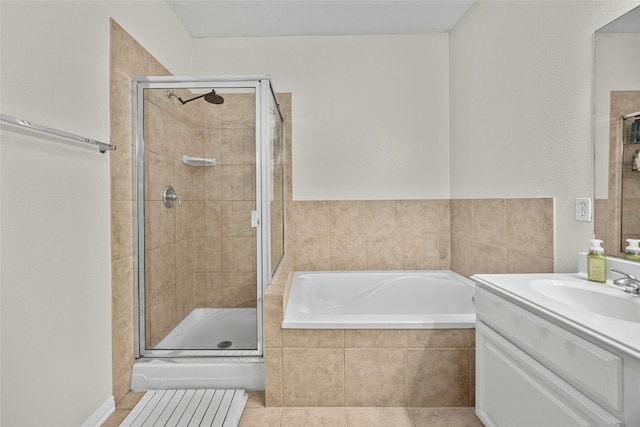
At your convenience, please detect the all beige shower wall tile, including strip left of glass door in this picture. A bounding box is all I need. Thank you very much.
[110,20,256,402]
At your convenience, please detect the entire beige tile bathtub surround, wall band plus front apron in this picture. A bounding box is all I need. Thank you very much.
[265,198,554,412]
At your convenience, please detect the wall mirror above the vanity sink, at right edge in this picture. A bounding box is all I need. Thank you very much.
[594,6,640,256]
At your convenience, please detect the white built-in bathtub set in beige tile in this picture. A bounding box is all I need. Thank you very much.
[282,270,476,329]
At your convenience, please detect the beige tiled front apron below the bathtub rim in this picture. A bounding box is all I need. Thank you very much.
[265,329,475,407]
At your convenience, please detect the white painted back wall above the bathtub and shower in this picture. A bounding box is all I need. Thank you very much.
[194,34,449,200]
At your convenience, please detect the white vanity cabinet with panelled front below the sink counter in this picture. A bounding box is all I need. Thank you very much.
[476,282,640,427]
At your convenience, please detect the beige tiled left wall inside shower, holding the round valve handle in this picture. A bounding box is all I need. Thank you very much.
[144,89,202,347]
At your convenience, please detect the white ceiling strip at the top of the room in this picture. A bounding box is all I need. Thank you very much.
[167,0,474,38]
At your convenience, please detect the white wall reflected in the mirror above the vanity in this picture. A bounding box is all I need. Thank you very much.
[595,33,640,199]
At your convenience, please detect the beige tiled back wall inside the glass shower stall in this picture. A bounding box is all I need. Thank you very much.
[192,94,256,308]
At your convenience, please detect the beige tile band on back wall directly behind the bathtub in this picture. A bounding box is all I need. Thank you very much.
[291,200,450,270]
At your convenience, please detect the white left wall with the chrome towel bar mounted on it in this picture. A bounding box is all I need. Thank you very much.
[0,1,192,426]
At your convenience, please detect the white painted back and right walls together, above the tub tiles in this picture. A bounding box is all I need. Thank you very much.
[194,1,638,271]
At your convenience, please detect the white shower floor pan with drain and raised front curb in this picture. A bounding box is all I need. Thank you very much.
[131,308,264,391]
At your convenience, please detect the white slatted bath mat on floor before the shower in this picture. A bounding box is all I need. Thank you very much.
[120,390,247,427]
